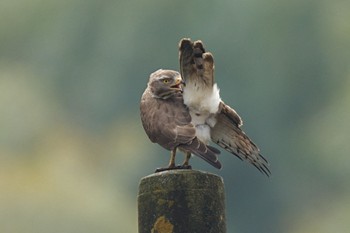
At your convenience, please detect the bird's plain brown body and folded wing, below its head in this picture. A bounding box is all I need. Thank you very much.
[140,90,221,168]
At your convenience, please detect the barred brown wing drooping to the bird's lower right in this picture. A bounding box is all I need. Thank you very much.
[210,102,271,176]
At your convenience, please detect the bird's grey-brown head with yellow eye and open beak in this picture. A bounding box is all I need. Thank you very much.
[148,69,184,99]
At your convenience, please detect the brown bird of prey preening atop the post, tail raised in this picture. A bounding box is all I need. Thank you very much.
[140,39,271,176]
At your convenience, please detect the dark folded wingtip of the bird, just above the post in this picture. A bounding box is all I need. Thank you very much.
[180,138,222,169]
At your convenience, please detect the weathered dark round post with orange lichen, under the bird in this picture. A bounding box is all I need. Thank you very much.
[138,170,226,233]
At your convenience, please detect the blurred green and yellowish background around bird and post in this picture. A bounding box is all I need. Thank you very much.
[0,0,350,233]
